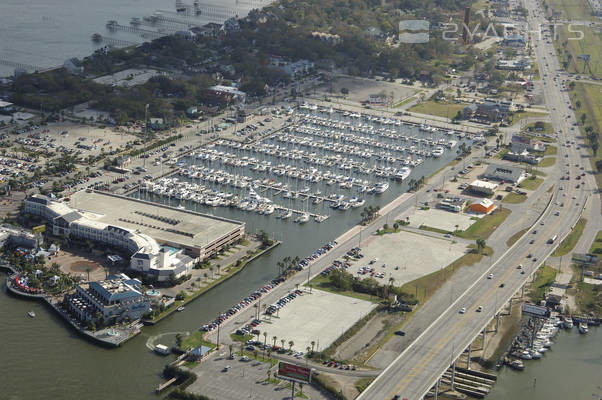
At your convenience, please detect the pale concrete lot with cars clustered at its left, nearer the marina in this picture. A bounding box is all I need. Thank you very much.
[348,231,466,286]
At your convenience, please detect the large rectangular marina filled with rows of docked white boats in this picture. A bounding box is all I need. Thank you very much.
[133,104,472,225]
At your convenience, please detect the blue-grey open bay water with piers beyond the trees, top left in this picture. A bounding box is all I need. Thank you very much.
[0,0,252,76]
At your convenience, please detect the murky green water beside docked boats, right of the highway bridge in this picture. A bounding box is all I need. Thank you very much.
[487,327,602,400]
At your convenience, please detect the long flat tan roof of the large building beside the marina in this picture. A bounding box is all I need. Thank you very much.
[69,191,242,248]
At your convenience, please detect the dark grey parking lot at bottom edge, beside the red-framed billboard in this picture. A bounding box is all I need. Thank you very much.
[187,349,327,400]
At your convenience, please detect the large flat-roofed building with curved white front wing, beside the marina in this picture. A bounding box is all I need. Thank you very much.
[23,191,245,281]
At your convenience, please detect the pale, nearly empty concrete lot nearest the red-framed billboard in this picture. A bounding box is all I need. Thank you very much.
[258,289,376,352]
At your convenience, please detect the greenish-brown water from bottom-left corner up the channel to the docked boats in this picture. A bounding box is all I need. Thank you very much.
[0,113,462,400]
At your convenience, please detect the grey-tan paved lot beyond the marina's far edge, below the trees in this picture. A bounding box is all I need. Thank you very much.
[321,77,416,104]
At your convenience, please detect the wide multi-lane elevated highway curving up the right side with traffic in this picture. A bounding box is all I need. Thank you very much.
[358,0,597,400]
